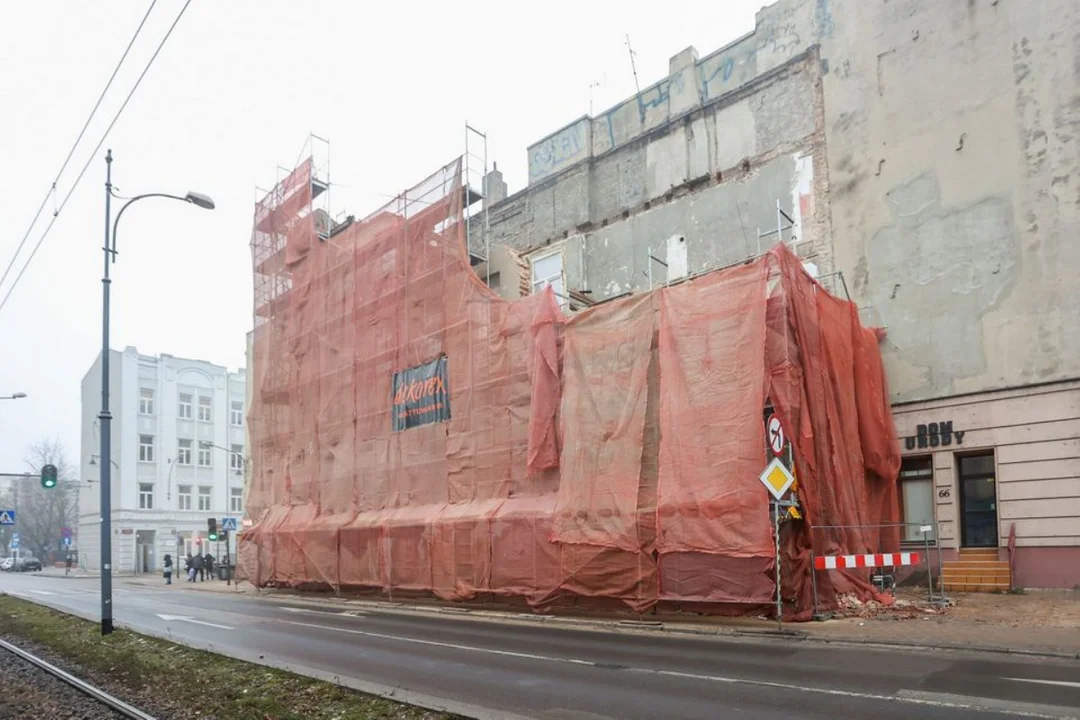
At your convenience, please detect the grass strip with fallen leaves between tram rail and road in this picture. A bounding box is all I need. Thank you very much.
[0,595,455,720]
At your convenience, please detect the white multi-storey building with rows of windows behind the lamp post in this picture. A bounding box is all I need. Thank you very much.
[78,347,247,573]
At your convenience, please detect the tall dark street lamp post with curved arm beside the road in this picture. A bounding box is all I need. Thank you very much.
[97,150,214,635]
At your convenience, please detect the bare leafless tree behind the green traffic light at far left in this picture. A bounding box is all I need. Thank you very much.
[12,438,79,559]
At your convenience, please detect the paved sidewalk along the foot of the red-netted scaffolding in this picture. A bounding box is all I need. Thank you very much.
[125,575,1080,658]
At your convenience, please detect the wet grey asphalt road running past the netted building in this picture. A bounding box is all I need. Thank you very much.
[0,573,1080,720]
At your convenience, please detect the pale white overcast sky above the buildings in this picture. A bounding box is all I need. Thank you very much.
[0,0,765,472]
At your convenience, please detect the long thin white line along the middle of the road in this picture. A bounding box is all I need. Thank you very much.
[271,620,1062,720]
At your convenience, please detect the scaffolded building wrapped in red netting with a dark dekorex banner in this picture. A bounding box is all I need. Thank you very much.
[239,156,900,619]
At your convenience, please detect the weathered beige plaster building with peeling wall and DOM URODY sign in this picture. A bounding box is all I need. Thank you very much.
[475,0,1080,586]
